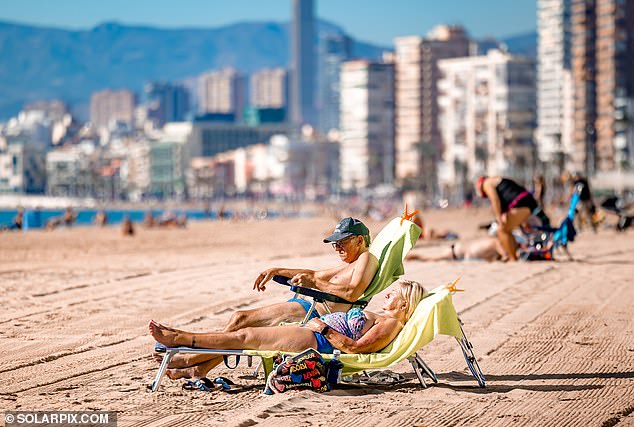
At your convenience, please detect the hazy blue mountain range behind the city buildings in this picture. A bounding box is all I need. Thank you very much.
[0,20,536,120]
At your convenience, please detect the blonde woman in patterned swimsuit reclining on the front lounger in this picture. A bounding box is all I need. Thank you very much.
[149,280,426,379]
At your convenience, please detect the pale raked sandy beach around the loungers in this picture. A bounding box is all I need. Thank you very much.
[0,209,634,427]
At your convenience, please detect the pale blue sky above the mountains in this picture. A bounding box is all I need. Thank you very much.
[0,0,536,45]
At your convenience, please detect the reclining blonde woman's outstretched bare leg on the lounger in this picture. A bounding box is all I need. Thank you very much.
[149,321,317,351]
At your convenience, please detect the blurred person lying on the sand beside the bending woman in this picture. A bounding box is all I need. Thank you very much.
[405,237,506,261]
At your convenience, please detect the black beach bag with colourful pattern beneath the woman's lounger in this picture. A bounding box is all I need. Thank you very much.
[266,348,330,394]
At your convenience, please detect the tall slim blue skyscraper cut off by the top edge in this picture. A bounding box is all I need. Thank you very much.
[290,0,318,126]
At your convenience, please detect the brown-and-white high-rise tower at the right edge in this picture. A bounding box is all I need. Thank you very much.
[571,0,634,175]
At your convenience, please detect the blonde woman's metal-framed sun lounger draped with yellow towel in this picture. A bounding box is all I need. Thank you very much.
[152,286,485,391]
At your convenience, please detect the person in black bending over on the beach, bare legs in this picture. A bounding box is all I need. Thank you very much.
[475,176,538,261]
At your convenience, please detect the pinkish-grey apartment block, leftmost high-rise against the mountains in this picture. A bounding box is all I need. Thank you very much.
[90,90,136,127]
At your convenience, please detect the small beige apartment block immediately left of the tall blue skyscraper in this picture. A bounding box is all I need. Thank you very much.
[251,68,288,109]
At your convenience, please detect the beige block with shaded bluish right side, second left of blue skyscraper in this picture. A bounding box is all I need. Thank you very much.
[199,68,245,121]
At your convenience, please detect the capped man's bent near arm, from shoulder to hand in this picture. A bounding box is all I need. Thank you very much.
[291,251,379,301]
